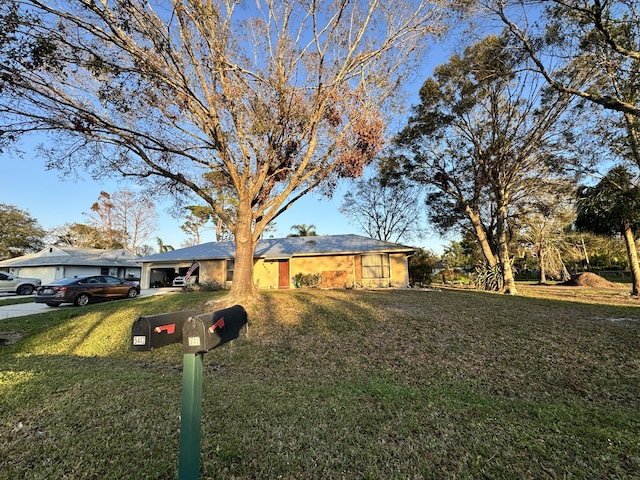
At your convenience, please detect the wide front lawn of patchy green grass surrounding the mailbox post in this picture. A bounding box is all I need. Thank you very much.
[0,290,640,479]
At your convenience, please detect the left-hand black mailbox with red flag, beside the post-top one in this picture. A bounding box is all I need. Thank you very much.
[131,310,200,352]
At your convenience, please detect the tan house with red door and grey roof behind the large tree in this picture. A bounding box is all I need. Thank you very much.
[140,235,415,289]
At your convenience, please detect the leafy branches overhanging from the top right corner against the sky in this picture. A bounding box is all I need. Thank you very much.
[490,0,640,117]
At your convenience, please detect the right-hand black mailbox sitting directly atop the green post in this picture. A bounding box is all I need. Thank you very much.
[182,305,247,353]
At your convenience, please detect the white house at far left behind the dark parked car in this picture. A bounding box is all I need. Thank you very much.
[0,246,140,284]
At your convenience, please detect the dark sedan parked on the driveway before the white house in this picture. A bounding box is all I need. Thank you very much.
[36,275,140,307]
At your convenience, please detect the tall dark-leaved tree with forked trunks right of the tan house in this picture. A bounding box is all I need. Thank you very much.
[385,35,571,293]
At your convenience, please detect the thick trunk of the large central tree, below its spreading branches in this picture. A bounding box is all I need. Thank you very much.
[229,201,258,302]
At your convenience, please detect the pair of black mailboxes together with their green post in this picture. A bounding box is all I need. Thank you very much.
[131,305,247,480]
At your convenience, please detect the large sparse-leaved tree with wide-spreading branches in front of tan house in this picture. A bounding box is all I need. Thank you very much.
[0,0,459,298]
